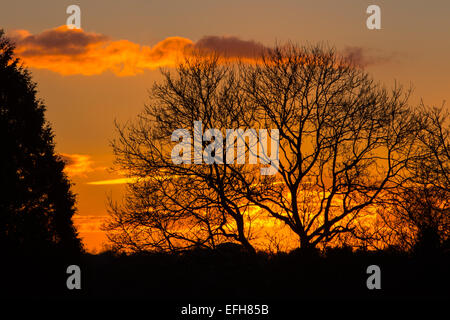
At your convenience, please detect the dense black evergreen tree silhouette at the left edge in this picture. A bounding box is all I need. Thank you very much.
[0,30,82,252]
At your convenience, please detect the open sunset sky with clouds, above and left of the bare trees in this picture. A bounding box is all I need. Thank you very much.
[0,0,450,251]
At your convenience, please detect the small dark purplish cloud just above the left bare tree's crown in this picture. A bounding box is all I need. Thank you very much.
[194,36,267,58]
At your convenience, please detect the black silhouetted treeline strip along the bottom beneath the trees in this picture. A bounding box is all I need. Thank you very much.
[0,248,450,303]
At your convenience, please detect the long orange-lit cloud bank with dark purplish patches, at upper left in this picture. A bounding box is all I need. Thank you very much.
[9,26,270,76]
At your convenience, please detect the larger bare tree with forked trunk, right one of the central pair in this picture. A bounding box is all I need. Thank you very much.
[238,44,414,248]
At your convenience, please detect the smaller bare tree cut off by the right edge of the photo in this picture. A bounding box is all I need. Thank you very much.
[380,104,450,252]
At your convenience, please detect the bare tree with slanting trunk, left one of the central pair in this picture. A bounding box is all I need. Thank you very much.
[106,52,256,252]
